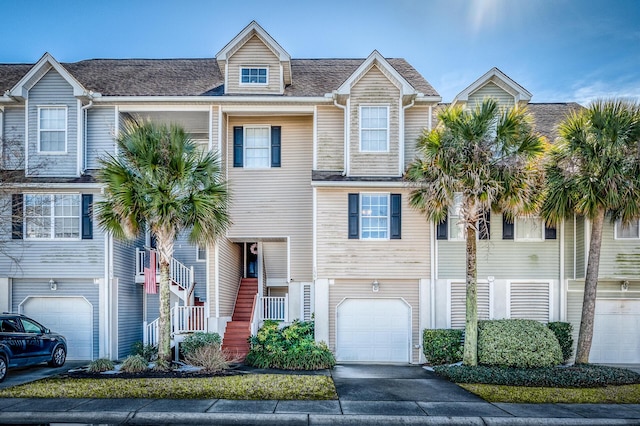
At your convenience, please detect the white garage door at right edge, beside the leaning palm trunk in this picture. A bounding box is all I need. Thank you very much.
[589,299,640,364]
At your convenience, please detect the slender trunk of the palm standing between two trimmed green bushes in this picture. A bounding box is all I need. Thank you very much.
[462,226,478,366]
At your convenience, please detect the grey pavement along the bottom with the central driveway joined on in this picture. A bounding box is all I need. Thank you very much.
[0,364,640,426]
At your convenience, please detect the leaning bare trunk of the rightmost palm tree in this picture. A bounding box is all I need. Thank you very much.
[575,208,605,364]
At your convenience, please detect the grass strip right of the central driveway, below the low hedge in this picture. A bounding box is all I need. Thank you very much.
[459,383,640,404]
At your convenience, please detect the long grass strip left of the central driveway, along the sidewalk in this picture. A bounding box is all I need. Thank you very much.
[0,374,338,400]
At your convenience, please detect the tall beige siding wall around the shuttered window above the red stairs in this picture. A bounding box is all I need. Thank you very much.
[225,116,313,282]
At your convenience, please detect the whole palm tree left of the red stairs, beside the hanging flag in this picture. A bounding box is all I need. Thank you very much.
[96,120,229,368]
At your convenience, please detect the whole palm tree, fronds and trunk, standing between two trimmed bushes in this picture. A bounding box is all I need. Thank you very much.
[405,99,545,365]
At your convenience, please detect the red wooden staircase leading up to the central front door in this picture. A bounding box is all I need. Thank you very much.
[222,278,258,361]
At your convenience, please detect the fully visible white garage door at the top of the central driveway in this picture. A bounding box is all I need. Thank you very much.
[336,299,411,362]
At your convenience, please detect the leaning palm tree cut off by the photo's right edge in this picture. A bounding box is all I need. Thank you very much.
[542,100,640,364]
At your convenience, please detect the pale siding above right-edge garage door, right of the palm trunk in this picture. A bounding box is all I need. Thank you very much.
[598,218,640,278]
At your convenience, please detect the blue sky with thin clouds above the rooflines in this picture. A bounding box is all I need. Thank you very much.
[0,0,640,105]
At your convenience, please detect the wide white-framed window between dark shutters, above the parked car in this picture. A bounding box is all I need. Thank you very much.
[24,194,81,239]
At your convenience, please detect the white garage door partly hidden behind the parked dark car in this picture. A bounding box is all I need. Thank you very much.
[22,297,93,360]
